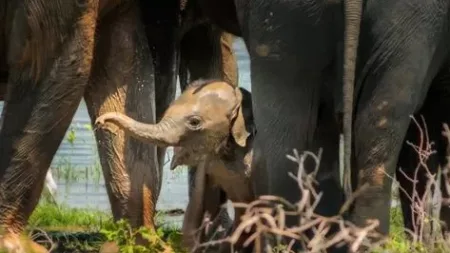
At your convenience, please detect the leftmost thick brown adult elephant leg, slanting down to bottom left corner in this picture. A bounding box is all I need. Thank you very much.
[0,1,97,249]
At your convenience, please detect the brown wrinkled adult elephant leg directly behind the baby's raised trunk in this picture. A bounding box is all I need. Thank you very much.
[85,5,162,228]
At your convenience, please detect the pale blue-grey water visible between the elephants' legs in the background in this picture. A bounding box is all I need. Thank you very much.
[0,39,251,221]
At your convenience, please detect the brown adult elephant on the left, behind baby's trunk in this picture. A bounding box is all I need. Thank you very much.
[0,0,236,250]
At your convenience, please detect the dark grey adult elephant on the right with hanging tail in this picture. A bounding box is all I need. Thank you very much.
[194,0,450,248]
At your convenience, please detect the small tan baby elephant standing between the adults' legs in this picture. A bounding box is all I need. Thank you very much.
[96,80,255,252]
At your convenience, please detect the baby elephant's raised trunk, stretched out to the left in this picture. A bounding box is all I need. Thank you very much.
[96,112,183,147]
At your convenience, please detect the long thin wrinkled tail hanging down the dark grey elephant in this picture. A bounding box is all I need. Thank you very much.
[343,0,362,197]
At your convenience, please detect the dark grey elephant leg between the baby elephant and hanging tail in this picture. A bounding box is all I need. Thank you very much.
[244,1,338,251]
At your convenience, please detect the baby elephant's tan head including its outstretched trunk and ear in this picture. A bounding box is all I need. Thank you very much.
[96,80,253,169]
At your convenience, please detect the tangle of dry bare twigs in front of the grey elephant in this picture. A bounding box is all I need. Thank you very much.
[195,147,383,253]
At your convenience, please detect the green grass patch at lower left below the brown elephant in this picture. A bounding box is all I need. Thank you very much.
[27,201,183,253]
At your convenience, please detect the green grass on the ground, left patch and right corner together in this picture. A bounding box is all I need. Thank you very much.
[22,201,449,253]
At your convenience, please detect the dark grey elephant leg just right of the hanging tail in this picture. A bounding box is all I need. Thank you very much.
[350,1,447,234]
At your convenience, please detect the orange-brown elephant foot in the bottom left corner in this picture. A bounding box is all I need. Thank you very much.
[0,233,48,253]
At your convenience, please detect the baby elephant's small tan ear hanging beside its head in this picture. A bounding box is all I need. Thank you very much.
[231,87,250,147]
